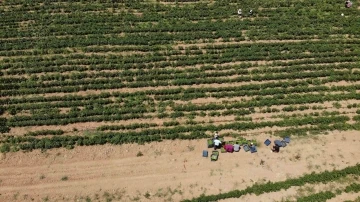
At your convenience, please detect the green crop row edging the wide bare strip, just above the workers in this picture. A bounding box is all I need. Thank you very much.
[1,116,359,151]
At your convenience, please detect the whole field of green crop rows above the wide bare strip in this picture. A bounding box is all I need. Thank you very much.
[0,0,360,151]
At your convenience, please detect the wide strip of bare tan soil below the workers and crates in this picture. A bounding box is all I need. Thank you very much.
[0,131,360,201]
